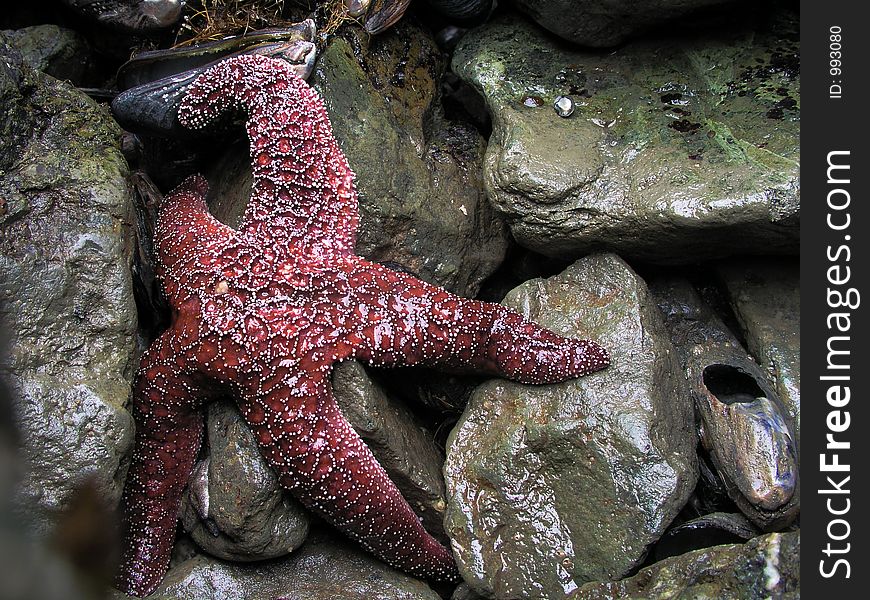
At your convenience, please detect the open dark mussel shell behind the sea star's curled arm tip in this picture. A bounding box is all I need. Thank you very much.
[112,19,317,137]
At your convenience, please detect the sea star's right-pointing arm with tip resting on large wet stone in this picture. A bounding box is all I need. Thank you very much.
[350,260,610,383]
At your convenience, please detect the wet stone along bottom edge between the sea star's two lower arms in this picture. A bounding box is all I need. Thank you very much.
[121,536,439,600]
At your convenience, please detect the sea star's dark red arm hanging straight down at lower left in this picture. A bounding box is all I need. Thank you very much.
[117,330,211,596]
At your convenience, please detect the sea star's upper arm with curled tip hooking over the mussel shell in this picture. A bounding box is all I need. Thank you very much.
[178,55,359,258]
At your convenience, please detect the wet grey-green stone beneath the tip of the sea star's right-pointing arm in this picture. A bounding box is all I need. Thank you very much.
[445,254,698,599]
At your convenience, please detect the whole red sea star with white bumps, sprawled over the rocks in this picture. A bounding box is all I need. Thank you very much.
[119,55,609,595]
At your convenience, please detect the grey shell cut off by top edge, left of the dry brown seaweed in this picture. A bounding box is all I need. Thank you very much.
[63,0,184,33]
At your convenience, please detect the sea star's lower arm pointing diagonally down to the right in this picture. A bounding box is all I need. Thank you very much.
[240,368,458,581]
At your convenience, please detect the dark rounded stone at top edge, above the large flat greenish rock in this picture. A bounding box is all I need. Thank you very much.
[513,0,733,47]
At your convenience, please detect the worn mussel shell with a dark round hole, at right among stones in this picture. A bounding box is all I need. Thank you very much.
[650,279,800,531]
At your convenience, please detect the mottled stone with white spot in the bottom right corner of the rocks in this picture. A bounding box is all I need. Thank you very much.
[572,532,800,600]
